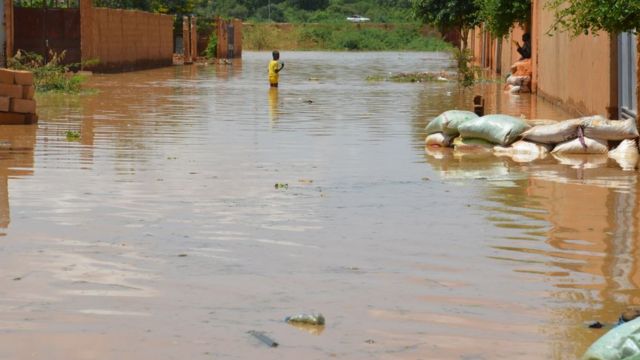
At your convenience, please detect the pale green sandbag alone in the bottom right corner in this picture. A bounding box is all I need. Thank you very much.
[581,318,640,360]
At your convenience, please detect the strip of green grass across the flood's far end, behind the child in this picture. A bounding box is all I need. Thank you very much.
[243,23,452,51]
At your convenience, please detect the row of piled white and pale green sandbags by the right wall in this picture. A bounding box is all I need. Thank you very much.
[426,110,640,170]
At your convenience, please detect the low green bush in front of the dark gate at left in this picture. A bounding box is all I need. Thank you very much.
[8,50,84,93]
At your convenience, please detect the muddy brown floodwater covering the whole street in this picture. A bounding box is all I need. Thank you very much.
[0,52,640,360]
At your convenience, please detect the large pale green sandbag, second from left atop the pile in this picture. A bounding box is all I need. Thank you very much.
[458,115,529,146]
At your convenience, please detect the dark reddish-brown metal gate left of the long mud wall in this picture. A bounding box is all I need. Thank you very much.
[14,2,81,64]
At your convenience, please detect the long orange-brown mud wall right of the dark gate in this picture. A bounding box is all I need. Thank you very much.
[80,0,173,71]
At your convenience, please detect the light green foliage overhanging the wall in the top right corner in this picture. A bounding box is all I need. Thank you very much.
[547,0,640,36]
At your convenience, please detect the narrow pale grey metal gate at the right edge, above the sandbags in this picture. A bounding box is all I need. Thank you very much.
[618,32,638,119]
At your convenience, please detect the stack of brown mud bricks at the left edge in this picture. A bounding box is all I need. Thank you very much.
[0,69,38,125]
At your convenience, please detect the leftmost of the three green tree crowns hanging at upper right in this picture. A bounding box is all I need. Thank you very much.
[413,0,481,50]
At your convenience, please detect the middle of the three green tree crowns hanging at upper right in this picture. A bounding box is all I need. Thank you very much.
[477,0,531,37]
